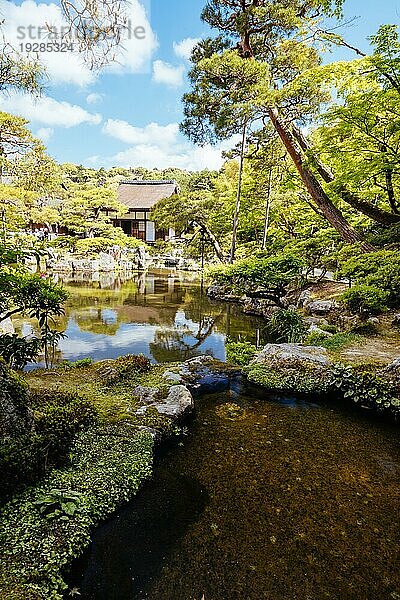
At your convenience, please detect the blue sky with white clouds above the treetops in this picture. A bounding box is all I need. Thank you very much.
[0,0,400,170]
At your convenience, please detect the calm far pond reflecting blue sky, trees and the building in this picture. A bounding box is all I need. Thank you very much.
[20,271,265,363]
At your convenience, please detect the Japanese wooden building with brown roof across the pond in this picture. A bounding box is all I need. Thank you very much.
[114,181,178,244]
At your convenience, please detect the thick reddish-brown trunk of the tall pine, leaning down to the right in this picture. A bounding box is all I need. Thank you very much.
[268,108,374,252]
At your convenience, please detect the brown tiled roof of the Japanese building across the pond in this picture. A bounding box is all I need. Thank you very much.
[118,181,178,209]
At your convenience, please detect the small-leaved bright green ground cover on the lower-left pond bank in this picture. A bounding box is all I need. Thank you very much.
[0,426,153,600]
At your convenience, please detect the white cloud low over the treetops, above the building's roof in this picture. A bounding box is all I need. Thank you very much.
[88,119,240,171]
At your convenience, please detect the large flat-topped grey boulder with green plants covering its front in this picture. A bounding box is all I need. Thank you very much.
[244,344,333,394]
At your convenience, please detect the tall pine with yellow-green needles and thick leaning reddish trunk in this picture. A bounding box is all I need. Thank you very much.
[182,0,378,250]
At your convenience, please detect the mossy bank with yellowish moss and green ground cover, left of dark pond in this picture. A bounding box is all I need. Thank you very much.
[0,358,183,600]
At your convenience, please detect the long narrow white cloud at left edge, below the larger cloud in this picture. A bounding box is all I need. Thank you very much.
[0,93,101,127]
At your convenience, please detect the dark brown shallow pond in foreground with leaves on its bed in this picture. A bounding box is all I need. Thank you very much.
[70,380,400,600]
